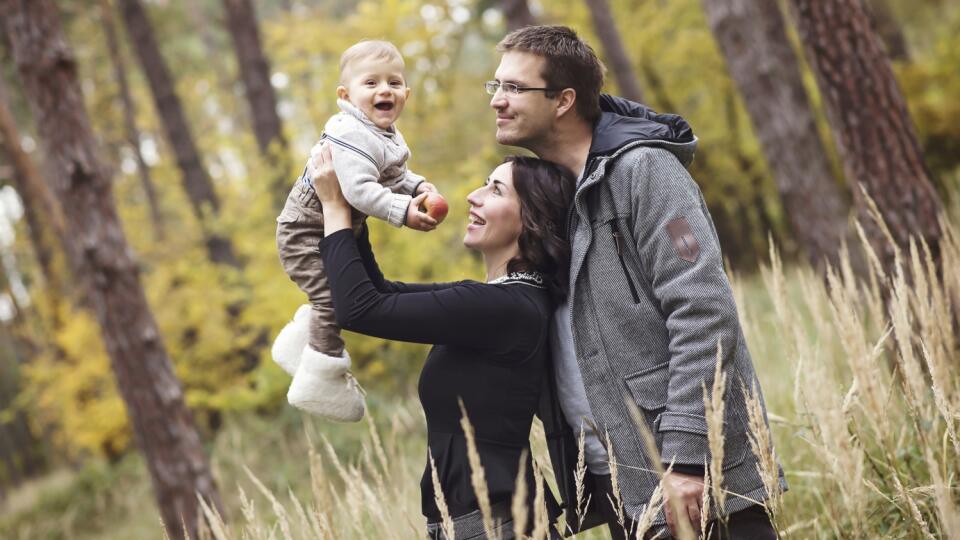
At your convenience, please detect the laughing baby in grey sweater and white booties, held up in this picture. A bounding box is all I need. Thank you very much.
[272,40,437,422]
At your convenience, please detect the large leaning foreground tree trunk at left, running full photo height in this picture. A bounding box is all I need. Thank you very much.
[0,0,221,539]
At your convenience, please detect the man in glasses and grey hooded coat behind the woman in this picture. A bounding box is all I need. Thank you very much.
[487,26,786,538]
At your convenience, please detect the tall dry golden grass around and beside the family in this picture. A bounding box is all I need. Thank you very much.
[0,220,960,540]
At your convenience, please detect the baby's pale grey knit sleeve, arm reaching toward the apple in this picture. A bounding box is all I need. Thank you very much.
[324,129,411,227]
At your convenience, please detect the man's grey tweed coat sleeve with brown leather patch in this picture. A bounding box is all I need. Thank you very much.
[631,147,741,467]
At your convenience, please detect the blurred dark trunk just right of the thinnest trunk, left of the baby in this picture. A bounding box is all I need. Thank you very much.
[119,0,239,266]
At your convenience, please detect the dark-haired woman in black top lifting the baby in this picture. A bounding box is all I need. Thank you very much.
[311,144,574,539]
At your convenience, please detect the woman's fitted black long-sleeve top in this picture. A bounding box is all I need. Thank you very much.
[320,229,552,521]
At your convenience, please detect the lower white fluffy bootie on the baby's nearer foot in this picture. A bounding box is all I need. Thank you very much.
[287,346,366,422]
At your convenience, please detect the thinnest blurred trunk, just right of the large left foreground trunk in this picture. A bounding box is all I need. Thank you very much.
[100,0,164,241]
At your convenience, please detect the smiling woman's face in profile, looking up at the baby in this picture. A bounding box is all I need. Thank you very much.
[463,163,523,255]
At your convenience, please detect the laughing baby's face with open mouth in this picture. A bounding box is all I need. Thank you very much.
[337,58,410,129]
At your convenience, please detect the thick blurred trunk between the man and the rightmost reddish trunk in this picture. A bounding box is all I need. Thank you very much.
[703,0,847,270]
